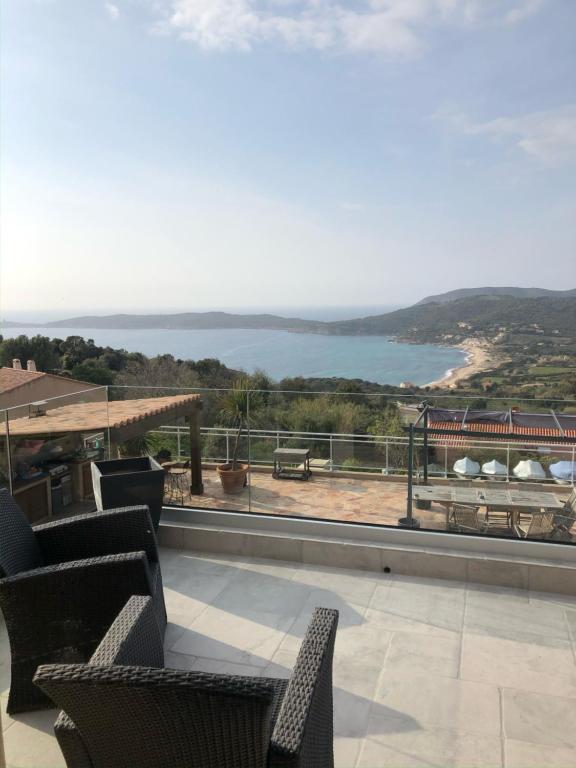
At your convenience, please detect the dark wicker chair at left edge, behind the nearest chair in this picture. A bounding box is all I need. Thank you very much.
[0,489,166,714]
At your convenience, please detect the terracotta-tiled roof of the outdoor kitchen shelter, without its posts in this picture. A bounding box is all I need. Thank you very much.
[0,394,202,442]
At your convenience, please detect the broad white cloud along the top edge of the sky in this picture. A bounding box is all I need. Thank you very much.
[155,0,547,55]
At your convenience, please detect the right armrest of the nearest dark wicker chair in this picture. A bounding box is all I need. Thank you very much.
[268,608,338,768]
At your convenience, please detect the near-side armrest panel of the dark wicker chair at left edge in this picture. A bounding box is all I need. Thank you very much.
[0,552,151,663]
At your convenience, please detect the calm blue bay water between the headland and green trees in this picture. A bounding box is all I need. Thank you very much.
[2,324,466,385]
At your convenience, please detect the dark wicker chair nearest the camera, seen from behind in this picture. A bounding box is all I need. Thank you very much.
[35,597,338,768]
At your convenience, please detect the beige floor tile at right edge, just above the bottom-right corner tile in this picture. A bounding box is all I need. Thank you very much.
[502,688,576,748]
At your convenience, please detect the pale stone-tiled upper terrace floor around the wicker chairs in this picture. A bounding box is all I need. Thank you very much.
[0,548,576,768]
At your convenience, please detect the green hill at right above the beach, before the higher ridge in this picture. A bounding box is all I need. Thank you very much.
[326,296,576,341]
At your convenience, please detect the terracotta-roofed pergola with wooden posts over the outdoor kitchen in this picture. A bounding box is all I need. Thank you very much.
[0,394,204,495]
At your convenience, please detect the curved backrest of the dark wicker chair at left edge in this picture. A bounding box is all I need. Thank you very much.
[0,488,44,578]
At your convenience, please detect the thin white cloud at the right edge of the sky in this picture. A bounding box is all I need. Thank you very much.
[434,104,576,166]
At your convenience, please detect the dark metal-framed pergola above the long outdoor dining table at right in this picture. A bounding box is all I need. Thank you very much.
[400,402,576,528]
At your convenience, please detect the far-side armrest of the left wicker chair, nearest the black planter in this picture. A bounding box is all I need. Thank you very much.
[34,506,158,564]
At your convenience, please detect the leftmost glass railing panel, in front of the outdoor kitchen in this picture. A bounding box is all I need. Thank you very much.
[1,387,109,523]
